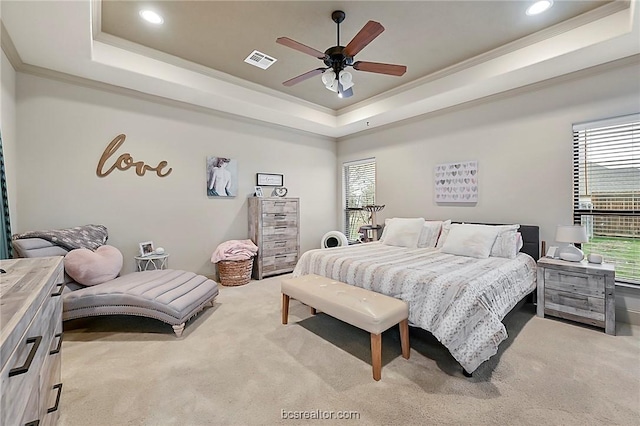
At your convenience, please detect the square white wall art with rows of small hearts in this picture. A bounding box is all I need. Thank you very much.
[435,161,478,203]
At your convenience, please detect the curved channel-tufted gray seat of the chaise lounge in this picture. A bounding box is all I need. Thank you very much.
[62,269,218,337]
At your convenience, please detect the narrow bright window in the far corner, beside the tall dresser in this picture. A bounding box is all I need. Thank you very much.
[343,158,376,241]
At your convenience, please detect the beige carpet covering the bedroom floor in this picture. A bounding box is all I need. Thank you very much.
[59,277,640,426]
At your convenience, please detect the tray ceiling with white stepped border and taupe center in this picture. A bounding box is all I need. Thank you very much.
[0,0,640,137]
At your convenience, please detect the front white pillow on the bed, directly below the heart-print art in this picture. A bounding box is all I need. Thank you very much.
[442,224,499,259]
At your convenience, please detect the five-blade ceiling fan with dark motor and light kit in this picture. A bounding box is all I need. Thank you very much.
[276,10,407,97]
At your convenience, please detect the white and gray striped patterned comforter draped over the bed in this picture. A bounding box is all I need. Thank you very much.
[293,242,536,373]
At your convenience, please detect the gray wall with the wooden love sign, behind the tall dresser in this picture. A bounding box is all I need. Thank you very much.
[14,73,338,275]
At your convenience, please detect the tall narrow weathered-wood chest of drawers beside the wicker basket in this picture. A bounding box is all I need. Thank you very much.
[249,197,300,280]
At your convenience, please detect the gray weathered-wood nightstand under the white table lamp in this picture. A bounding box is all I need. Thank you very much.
[537,257,616,335]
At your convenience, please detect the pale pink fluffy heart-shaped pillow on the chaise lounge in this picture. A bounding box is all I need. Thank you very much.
[64,245,123,285]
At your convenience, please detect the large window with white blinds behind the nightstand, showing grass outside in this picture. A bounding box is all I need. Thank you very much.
[573,114,640,284]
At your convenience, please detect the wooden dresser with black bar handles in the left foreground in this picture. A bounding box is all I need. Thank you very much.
[0,256,64,426]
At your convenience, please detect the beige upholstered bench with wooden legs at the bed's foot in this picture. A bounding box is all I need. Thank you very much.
[281,275,409,380]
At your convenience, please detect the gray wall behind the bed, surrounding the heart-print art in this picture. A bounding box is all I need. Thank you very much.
[338,61,640,319]
